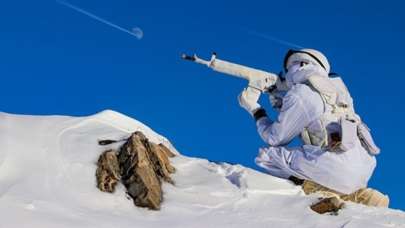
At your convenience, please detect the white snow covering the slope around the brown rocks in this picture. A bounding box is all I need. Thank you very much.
[0,110,405,228]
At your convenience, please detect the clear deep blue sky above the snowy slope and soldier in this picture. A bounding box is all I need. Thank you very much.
[0,0,405,209]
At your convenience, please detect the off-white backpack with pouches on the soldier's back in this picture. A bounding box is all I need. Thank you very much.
[301,74,380,155]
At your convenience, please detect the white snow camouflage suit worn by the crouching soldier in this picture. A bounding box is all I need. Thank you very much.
[255,65,376,194]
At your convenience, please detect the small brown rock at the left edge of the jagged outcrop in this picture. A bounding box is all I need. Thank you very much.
[96,150,121,192]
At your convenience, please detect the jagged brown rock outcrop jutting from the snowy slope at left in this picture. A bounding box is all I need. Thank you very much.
[96,131,175,210]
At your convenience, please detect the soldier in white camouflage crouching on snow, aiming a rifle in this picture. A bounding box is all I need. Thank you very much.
[239,49,389,207]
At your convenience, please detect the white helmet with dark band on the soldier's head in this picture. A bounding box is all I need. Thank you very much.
[284,49,330,74]
